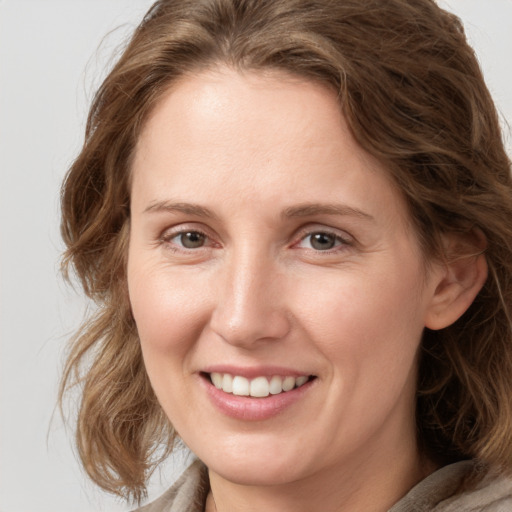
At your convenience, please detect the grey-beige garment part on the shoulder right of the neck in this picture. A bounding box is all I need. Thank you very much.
[389,461,512,512]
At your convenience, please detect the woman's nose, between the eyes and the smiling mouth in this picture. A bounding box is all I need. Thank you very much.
[210,245,290,349]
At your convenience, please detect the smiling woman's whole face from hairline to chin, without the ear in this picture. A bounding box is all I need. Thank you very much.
[128,68,435,484]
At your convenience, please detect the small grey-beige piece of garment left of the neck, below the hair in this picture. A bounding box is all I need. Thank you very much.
[133,460,209,512]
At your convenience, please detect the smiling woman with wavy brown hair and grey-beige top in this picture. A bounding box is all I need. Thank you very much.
[62,0,512,512]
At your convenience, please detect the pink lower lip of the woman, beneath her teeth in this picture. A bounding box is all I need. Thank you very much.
[201,378,316,421]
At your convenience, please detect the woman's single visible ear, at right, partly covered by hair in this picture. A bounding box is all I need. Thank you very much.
[425,229,487,330]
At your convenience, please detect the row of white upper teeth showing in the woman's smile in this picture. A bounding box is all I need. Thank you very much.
[210,373,309,398]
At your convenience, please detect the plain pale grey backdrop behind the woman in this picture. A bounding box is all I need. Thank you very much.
[0,0,512,512]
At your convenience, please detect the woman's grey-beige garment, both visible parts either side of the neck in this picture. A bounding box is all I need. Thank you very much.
[134,460,512,512]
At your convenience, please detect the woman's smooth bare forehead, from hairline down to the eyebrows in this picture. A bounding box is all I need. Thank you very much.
[132,68,403,230]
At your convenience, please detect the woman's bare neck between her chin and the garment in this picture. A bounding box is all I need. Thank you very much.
[206,440,435,512]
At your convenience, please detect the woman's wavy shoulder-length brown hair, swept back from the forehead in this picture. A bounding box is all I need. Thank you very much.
[60,0,512,500]
